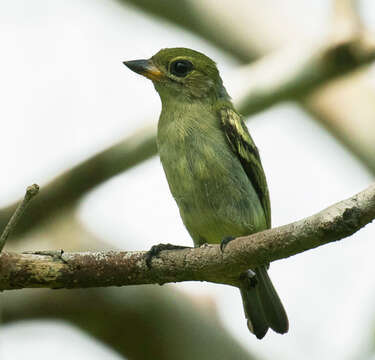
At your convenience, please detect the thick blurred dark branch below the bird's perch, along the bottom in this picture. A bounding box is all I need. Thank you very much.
[2,286,255,360]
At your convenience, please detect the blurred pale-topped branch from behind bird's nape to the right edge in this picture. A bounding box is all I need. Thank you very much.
[235,32,375,116]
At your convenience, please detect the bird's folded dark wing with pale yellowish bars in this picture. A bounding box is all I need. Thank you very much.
[218,106,271,228]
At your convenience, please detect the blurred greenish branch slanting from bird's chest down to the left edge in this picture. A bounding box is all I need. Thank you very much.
[0,126,157,239]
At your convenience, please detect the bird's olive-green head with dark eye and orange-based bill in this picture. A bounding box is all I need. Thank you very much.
[124,48,228,101]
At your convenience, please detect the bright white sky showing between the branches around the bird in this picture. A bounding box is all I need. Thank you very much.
[0,0,375,360]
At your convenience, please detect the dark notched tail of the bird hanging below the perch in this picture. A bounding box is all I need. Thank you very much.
[240,266,289,339]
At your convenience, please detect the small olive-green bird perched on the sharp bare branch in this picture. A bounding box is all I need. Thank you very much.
[124,48,289,339]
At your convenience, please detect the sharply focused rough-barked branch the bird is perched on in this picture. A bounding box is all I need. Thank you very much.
[0,184,375,290]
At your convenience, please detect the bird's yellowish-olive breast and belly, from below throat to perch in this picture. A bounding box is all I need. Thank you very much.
[158,105,264,244]
